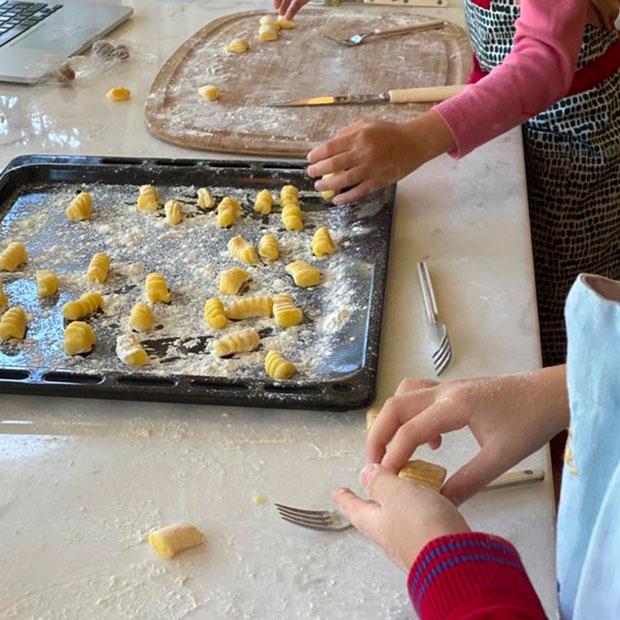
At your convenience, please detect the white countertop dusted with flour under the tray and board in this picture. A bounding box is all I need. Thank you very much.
[0,0,555,619]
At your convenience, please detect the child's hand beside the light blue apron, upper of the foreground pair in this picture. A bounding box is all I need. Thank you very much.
[366,366,569,505]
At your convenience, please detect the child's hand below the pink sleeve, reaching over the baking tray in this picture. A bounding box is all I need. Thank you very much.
[307,111,455,205]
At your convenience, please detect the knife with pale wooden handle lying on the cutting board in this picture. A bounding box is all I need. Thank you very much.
[267,84,465,108]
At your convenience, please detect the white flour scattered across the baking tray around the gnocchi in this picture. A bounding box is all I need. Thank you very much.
[0,184,374,380]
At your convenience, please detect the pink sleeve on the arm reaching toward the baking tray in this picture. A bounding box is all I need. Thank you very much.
[433,0,588,157]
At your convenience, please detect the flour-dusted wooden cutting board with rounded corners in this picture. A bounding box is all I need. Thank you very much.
[146,7,471,157]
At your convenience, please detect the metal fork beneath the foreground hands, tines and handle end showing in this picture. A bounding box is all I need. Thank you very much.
[275,469,545,532]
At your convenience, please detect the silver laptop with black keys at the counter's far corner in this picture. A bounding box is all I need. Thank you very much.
[0,0,133,84]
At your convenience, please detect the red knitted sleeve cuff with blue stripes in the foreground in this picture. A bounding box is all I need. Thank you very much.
[407,532,546,620]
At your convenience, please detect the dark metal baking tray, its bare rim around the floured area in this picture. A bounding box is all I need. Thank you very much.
[0,155,395,410]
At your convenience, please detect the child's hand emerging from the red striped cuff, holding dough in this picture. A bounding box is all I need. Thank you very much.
[332,465,469,570]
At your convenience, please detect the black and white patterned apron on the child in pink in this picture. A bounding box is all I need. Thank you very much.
[465,0,620,366]
